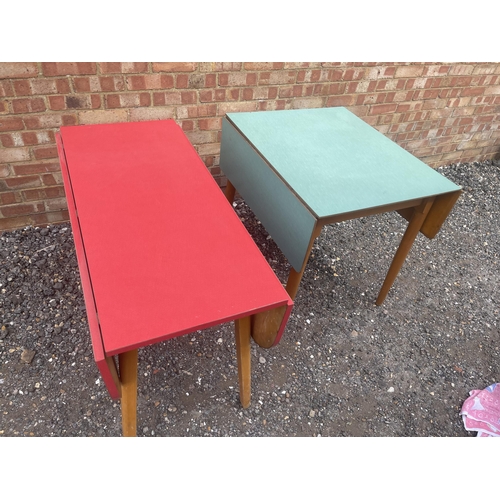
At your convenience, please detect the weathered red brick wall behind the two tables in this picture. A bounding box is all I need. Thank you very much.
[0,62,500,231]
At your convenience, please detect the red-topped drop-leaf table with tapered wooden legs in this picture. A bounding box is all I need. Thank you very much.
[57,120,292,435]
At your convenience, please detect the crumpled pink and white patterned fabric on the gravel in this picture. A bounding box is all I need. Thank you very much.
[460,384,500,437]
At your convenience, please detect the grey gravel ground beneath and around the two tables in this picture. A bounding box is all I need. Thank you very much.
[0,161,500,437]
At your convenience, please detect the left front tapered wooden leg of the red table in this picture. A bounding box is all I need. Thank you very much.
[118,349,138,437]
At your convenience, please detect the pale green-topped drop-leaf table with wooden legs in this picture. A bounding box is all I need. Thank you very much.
[220,107,461,344]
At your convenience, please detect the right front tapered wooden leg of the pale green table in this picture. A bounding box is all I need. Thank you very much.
[375,198,434,306]
